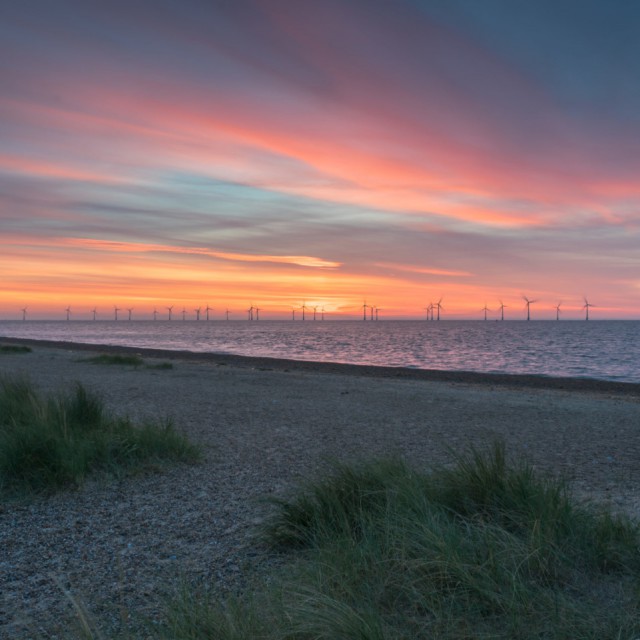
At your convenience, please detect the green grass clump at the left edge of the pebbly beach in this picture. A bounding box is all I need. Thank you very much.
[0,379,198,495]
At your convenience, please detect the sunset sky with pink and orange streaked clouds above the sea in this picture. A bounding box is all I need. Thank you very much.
[0,0,640,319]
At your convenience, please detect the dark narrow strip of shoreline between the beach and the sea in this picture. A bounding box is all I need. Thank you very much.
[0,336,640,397]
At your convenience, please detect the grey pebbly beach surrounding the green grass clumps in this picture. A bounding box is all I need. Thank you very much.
[0,338,640,638]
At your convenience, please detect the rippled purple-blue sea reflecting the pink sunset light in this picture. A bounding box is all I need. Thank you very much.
[0,320,640,383]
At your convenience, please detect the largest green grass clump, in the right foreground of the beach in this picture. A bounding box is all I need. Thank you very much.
[167,444,640,640]
